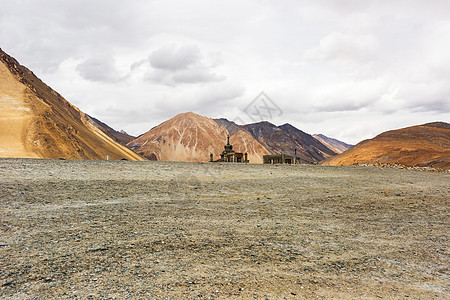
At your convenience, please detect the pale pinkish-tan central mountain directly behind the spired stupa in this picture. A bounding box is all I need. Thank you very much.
[127,112,268,163]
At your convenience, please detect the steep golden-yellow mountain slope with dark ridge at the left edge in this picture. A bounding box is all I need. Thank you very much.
[0,49,143,160]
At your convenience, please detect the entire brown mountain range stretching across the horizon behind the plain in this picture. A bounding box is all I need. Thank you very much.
[0,49,450,169]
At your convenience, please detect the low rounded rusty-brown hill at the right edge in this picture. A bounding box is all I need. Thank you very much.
[321,122,450,169]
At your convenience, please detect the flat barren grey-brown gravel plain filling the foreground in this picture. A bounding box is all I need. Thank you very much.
[0,159,450,299]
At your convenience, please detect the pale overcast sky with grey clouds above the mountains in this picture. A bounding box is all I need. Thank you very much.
[0,0,450,143]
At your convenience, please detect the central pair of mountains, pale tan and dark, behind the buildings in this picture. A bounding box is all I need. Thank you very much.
[127,112,352,163]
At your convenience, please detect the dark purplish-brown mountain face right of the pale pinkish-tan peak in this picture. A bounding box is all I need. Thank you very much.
[214,119,336,163]
